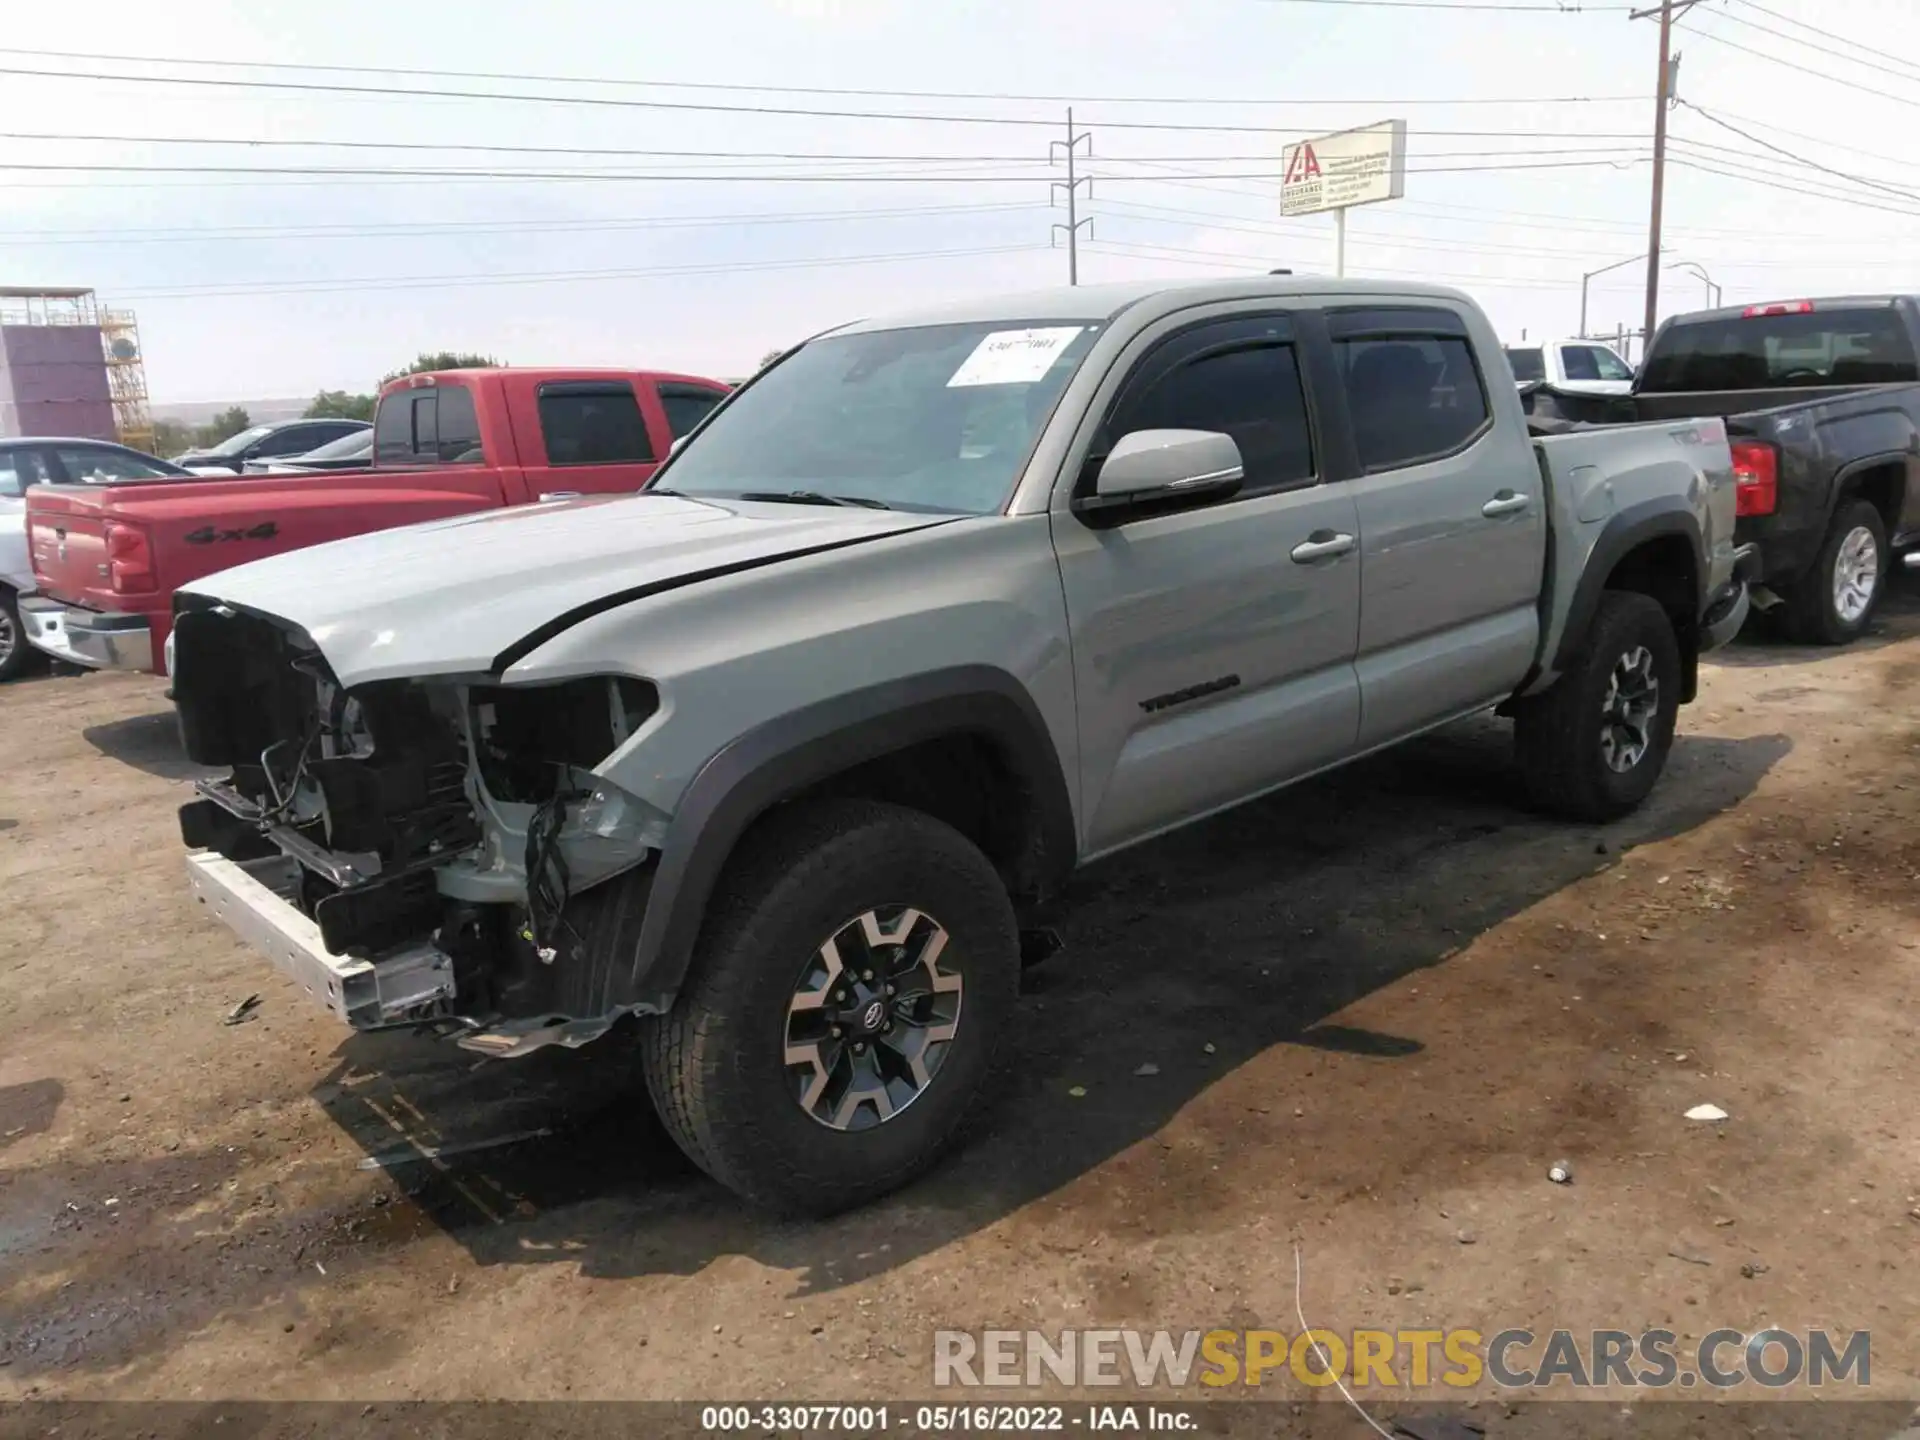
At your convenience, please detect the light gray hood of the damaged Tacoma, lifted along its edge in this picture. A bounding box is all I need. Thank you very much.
[180,495,952,685]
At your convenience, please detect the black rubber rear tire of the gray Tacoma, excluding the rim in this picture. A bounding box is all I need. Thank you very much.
[1513,589,1680,824]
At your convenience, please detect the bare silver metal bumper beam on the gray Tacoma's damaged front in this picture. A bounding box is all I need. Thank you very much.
[186,851,453,1029]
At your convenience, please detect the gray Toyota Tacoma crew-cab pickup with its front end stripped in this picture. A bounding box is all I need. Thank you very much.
[175,276,1747,1213]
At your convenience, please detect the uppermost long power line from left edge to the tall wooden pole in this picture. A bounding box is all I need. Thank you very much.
[0,44,1645,108]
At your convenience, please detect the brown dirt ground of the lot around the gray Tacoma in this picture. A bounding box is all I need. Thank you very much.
[0,584,1920,1404]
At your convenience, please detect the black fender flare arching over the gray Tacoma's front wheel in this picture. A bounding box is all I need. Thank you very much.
[620,664,1077,1010]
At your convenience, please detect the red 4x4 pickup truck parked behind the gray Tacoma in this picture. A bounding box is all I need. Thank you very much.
[19,369,728,674]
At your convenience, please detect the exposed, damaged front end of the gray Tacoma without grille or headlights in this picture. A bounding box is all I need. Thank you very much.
[175,605,668,1056]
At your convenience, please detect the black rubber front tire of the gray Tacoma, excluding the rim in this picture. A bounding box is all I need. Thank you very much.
[639,801,1020,1215]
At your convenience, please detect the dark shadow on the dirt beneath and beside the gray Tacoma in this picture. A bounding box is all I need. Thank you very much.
[299,720,1791,1292]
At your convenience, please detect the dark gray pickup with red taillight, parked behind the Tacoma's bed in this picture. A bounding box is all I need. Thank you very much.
[1521,296,1920,645]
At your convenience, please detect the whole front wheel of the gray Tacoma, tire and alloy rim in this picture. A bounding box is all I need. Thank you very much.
[641,801,1020,1215]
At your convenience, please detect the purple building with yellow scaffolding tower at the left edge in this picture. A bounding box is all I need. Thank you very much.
[0,286,154,449]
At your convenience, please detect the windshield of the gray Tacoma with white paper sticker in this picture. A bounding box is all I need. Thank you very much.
[660,321,1100,515]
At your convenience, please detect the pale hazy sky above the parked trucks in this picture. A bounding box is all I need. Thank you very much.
[0,0,1920,403]
